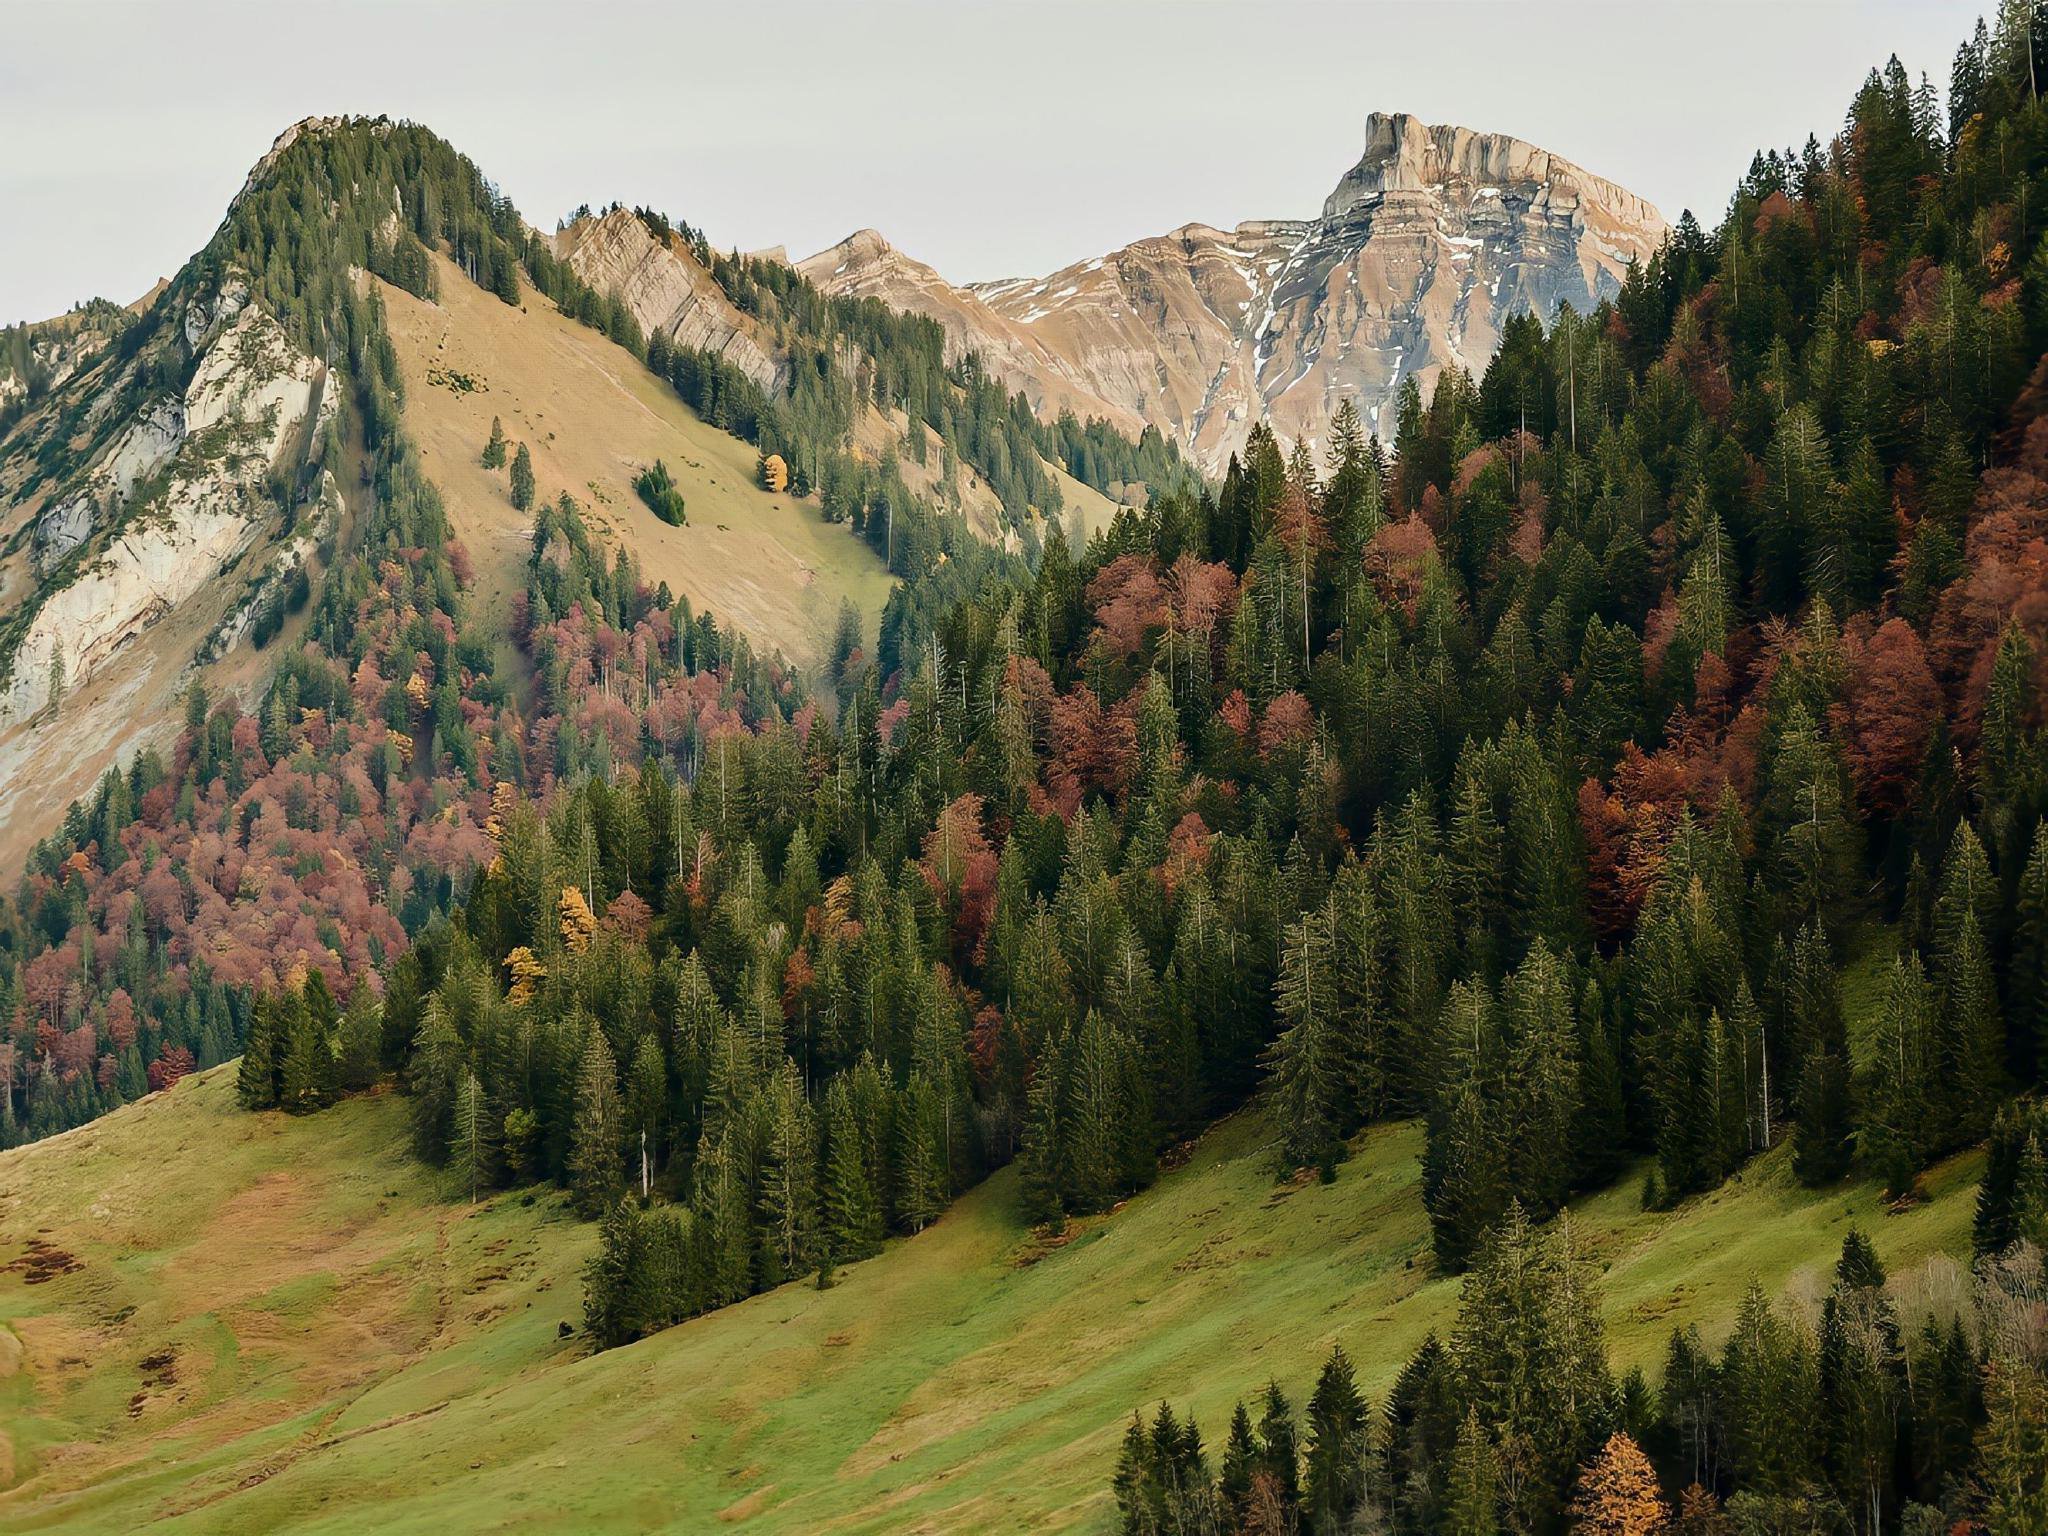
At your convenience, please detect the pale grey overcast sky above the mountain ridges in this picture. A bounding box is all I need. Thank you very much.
[0,0,1991,319]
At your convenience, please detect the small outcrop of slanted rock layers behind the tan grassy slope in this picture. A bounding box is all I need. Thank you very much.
[555,209,776,389]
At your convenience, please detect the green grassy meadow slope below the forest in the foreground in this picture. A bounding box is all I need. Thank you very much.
[0,1069,1976,1536]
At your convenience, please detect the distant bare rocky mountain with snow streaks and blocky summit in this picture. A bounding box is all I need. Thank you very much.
[799,113,1665,473]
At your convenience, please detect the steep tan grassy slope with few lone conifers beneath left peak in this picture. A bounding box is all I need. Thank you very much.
[385,250,891,664]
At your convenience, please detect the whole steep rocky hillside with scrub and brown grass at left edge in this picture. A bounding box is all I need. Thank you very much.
[0,272,348,868]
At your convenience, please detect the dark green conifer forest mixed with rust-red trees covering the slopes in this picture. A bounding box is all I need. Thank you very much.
[12,0,2048,1536]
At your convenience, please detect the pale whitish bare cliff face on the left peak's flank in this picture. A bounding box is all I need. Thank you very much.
[0,283,334,725]
